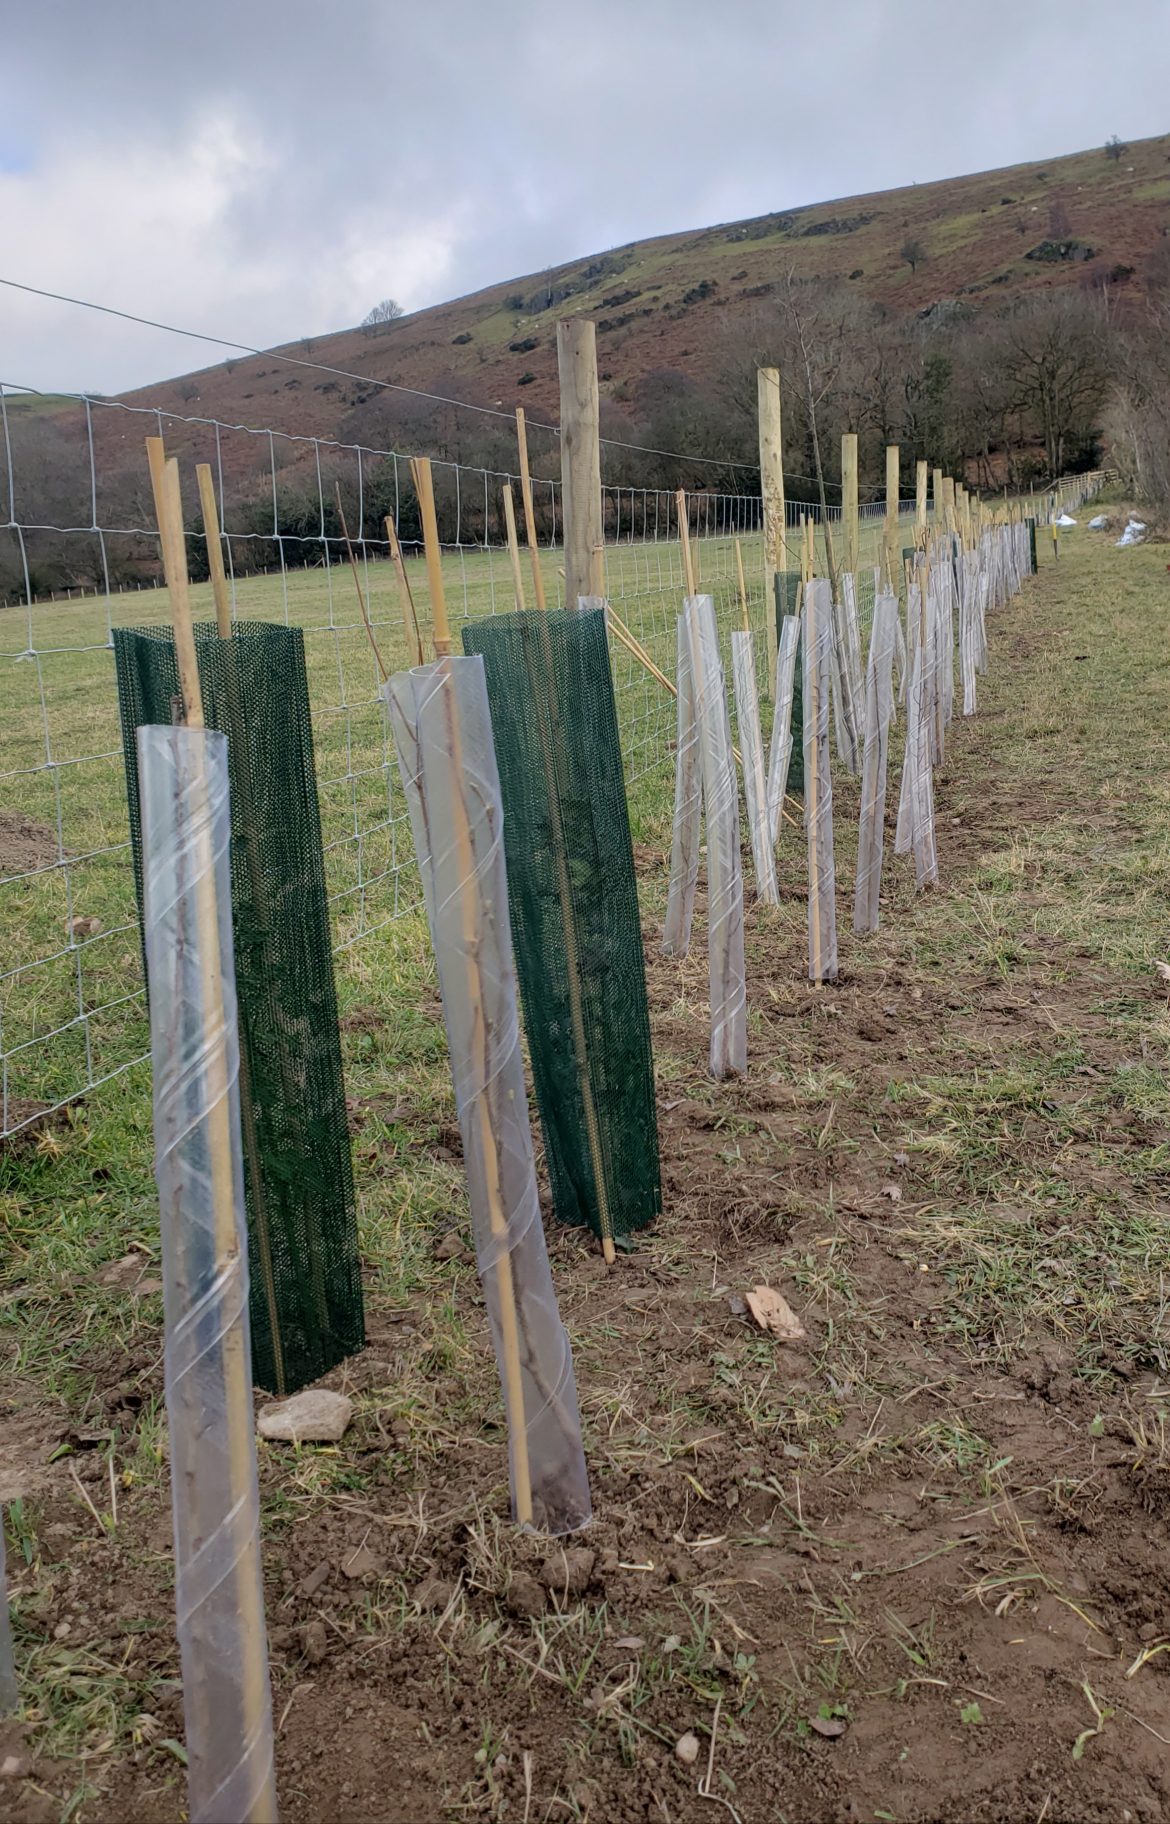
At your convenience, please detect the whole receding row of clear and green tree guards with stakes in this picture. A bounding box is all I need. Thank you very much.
[45,319,1102,1824]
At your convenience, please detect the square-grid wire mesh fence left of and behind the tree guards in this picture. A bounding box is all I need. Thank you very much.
[0,383,770,1135]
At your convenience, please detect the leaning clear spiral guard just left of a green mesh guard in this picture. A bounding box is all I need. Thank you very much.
[381,657,591,1534]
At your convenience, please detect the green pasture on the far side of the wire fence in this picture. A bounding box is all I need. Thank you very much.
[0,503,890,1133]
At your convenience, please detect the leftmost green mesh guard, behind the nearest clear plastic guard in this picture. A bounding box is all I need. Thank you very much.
[113,622,365,1394]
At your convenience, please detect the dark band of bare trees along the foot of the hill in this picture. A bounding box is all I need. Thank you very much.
[0,243,1170,602]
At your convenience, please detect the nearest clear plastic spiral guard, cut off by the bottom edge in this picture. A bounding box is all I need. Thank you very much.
[139,726,276,1824]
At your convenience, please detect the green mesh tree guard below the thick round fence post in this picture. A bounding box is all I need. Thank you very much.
[464,609,663,1238]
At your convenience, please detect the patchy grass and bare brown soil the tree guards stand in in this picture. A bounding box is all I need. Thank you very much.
[0,507,1170,1824]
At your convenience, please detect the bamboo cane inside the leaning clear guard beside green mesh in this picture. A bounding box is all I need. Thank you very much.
[411,456,533,1527]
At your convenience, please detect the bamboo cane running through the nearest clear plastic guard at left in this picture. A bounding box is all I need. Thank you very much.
[146,438,276,1824]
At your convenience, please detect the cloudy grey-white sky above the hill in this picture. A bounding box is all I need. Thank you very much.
[0,0,1170,392]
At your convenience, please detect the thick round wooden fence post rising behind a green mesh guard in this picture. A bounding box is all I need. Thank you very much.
[557,317,606,607]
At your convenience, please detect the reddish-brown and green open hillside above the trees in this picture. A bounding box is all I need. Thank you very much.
[126,135,1170,438]
